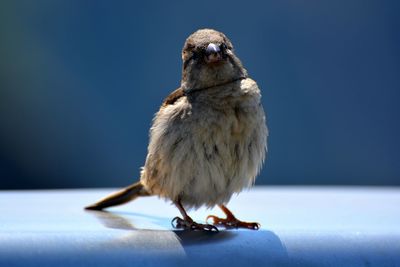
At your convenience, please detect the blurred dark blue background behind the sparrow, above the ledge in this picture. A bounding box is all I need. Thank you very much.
[0,0,400,189]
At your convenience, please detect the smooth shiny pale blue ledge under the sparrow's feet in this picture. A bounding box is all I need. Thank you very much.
[0,187,400,266]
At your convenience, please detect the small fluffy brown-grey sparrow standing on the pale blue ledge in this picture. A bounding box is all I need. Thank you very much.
[86,29,268,231]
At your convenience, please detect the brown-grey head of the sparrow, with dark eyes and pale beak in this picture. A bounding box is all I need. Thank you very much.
[181,29,247,91]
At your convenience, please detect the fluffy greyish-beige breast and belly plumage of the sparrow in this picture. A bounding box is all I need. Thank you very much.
[141,79,268,207]
